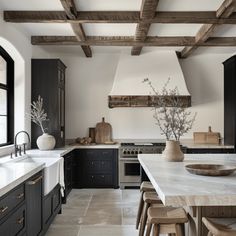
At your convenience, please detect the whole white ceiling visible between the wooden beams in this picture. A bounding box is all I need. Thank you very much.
[0,0,236,53]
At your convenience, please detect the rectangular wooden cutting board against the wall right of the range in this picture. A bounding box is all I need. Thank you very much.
[193,126,221,144]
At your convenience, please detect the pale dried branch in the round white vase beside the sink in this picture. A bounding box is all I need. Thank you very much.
[28,95,48,133]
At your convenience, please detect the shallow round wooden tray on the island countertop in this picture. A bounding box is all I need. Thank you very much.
[185,164,236,176]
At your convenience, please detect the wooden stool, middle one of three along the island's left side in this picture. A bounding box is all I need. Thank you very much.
[139,192,163,236]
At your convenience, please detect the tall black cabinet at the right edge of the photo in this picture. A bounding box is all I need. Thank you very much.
[223,55,236,146]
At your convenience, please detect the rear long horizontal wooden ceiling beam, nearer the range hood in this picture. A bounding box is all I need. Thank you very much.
[31,36,236,47]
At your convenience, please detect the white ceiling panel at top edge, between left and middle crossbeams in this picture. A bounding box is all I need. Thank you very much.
[75,0,142,11]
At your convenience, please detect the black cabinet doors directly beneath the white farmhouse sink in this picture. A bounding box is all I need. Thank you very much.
[42,184,61,235]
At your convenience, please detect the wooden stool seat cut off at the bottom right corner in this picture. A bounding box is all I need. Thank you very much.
[202,217,236,236]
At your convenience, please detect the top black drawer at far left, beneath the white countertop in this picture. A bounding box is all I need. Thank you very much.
[0,185,25,219]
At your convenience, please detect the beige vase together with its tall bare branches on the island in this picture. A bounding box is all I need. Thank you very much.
[143,78,197,161]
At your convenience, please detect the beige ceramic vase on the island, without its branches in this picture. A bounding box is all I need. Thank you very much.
[162,140,184,162]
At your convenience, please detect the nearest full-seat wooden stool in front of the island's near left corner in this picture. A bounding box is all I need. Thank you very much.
[146,207,188,236]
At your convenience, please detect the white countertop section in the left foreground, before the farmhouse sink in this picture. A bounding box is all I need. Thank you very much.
[0,162,44,197]
